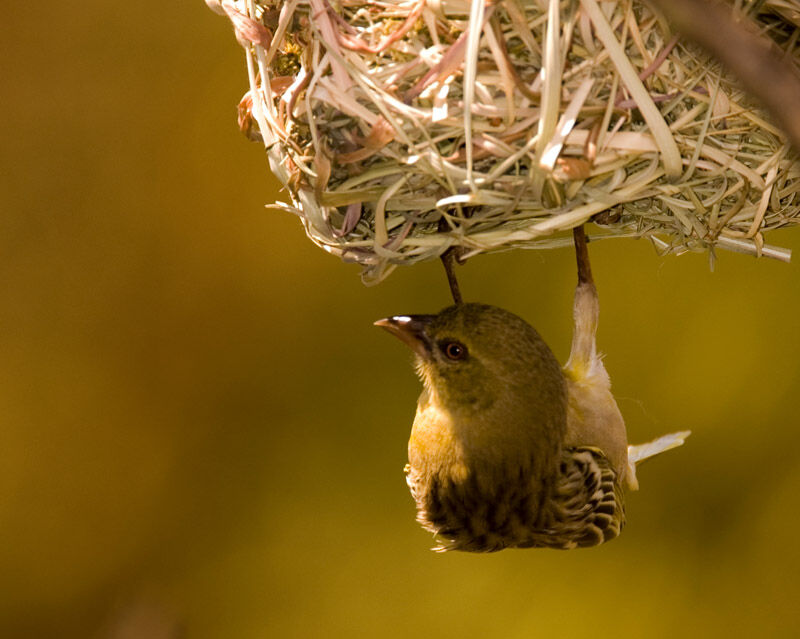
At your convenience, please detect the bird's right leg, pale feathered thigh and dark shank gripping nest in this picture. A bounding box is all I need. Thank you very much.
[565,225,600,372]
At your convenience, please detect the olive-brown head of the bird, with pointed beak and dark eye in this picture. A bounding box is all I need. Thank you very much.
[375,304,565,418]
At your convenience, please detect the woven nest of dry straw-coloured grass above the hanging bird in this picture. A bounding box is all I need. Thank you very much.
[210,0,800,283]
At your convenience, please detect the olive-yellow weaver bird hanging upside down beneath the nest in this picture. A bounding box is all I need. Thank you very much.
[376,227,689,552]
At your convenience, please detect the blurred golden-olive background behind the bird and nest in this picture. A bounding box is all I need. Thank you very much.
[0,0,800,639]
